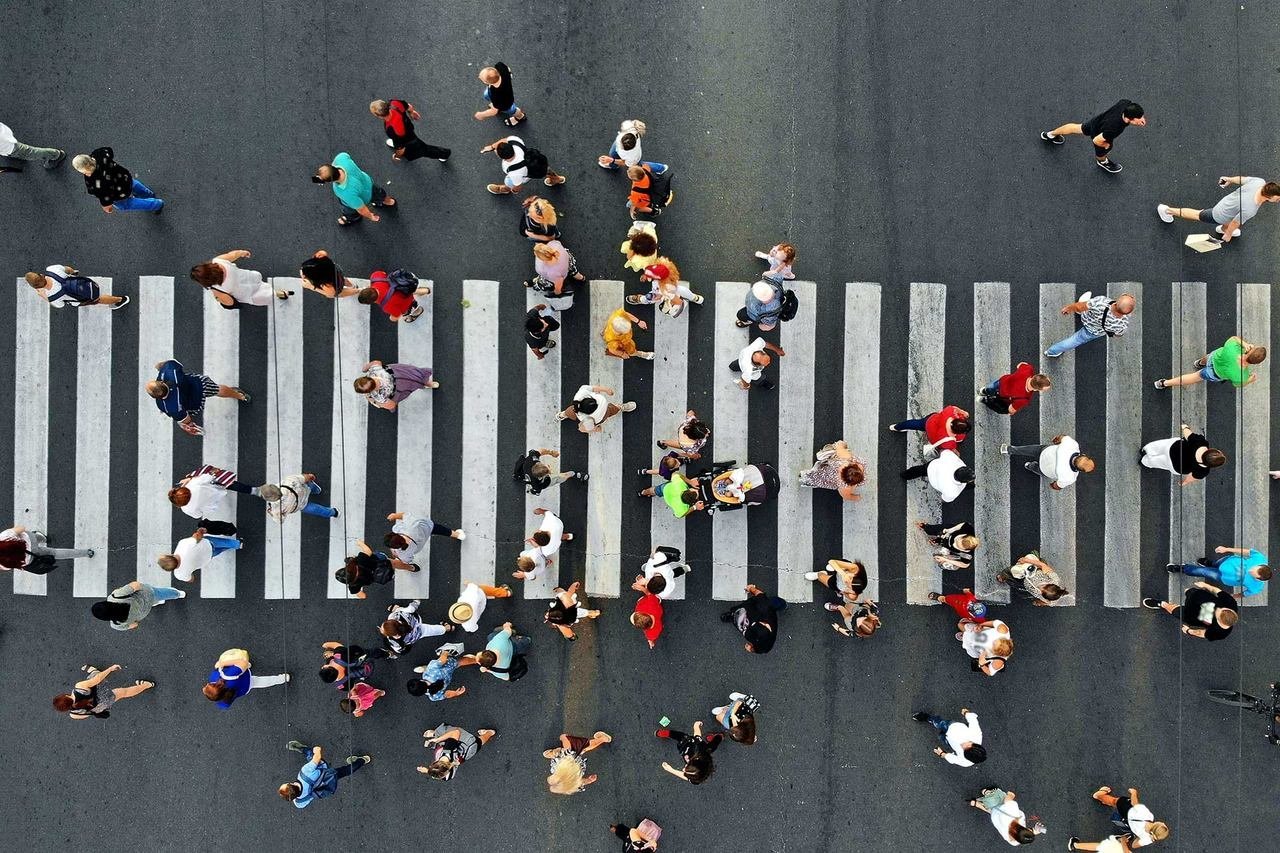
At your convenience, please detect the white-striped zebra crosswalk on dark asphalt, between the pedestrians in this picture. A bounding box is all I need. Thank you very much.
[12,275,1271,607]
